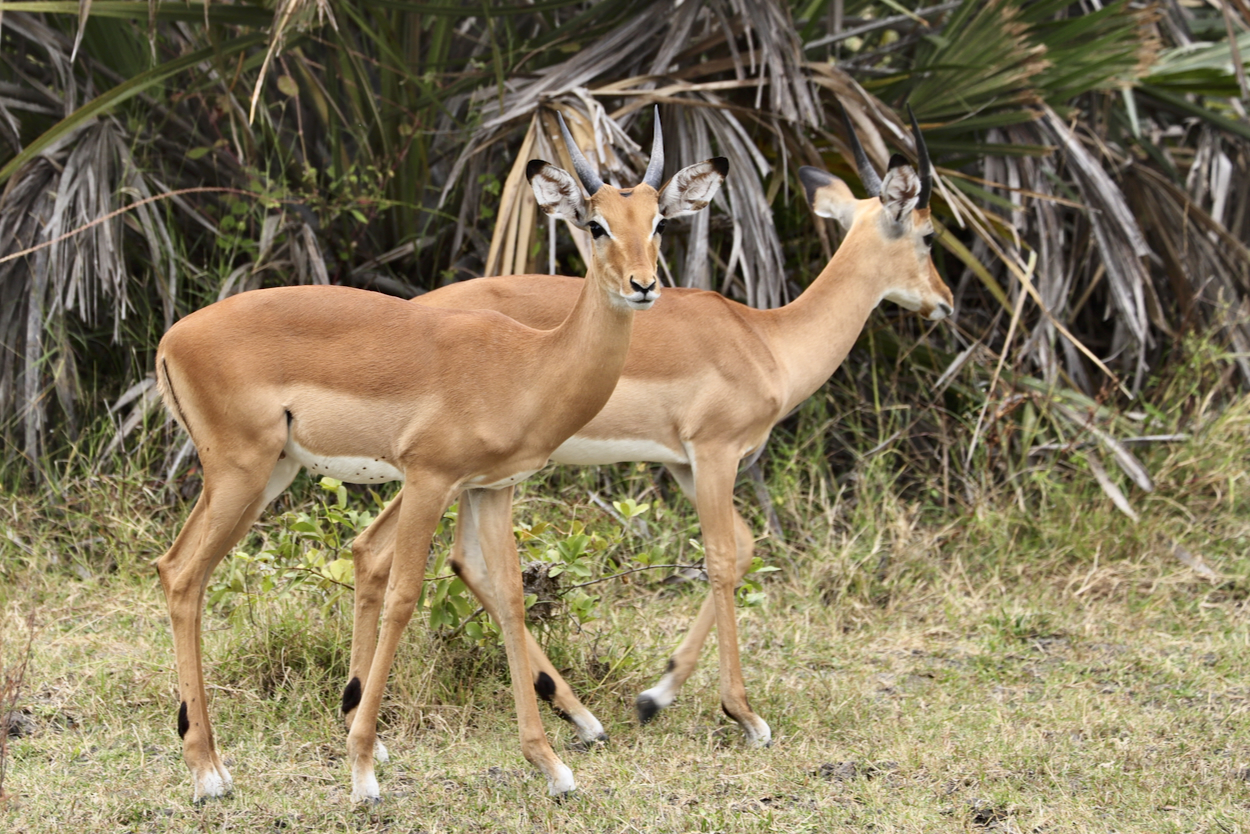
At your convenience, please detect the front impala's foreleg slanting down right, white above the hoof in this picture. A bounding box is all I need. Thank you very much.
[461,486,576,796]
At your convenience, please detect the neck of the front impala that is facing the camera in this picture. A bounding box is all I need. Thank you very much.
[540,261,635,443]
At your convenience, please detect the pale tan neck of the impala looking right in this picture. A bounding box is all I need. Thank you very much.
[761,235,883,413]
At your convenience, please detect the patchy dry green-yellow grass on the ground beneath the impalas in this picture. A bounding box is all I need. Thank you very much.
[0,403,1250,833]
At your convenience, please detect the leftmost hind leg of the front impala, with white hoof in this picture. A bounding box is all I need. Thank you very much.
[156,451,299,803]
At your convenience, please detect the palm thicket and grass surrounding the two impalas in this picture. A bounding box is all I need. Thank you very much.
[0,0,1250,831]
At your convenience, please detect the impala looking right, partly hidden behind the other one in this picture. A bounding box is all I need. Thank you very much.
[353,104,954,746]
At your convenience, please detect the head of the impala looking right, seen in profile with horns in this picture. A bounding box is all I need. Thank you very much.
[799,106,954,321]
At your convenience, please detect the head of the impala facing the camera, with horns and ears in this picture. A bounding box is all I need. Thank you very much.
[525,108,729,310]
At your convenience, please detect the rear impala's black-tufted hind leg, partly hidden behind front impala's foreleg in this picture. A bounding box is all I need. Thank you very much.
[451,485,608,744]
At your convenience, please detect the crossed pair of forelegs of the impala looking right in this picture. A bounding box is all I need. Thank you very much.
[635,455,773,746]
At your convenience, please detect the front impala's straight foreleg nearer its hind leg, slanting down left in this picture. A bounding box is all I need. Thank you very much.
[348,482,450,801]
